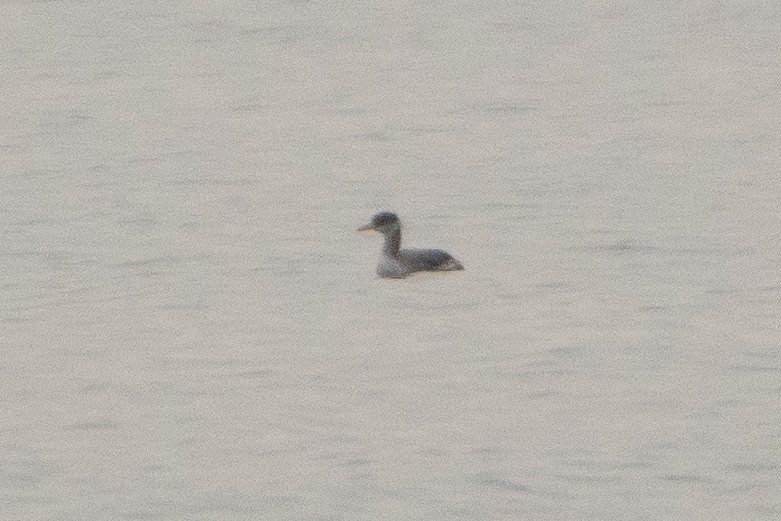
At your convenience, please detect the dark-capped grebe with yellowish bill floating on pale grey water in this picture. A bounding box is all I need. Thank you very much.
[358,212,464,279]
